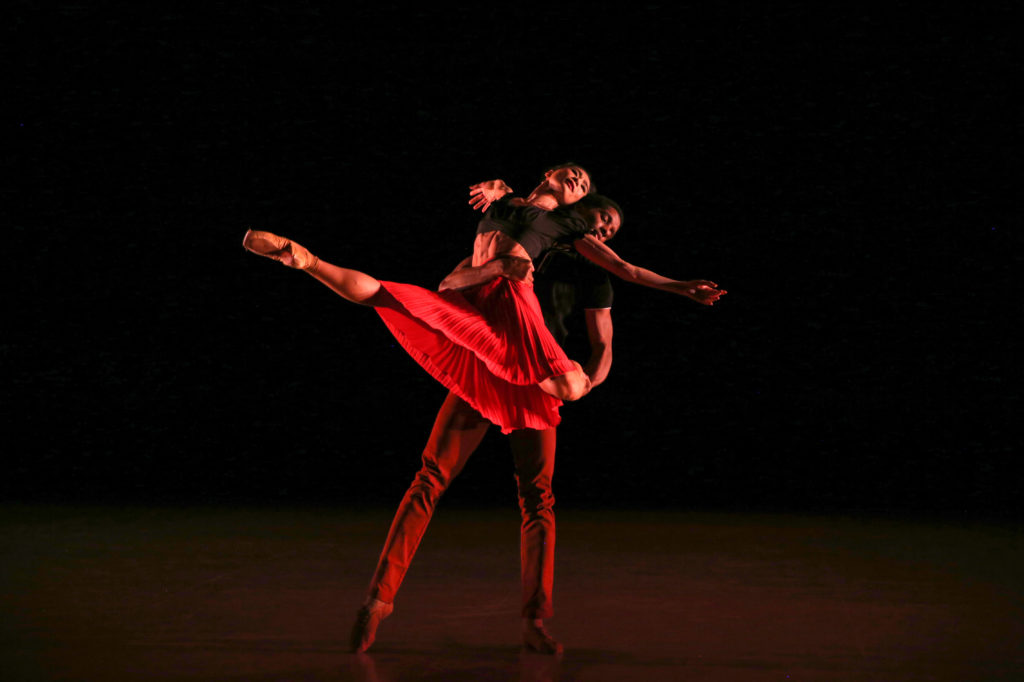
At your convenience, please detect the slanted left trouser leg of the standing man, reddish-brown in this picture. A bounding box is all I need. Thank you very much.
[369,392,490,603]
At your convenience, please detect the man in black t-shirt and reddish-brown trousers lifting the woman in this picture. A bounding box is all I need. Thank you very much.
[351,195,622,654]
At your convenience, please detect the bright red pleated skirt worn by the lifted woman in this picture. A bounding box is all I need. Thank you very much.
[376,278,575,433]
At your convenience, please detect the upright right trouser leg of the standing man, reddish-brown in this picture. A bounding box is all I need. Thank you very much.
[509,427,557,620]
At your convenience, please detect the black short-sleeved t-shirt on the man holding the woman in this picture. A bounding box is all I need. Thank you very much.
[534,247,613,361]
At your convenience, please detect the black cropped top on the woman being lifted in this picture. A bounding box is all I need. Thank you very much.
[476,198,587,260]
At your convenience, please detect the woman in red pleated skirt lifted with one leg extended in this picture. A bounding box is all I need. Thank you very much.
[243,166,725,433]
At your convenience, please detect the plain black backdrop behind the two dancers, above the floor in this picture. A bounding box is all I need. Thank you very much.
[6,3,1022,517]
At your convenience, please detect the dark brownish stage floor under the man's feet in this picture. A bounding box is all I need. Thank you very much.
[0,502,1024,682]
